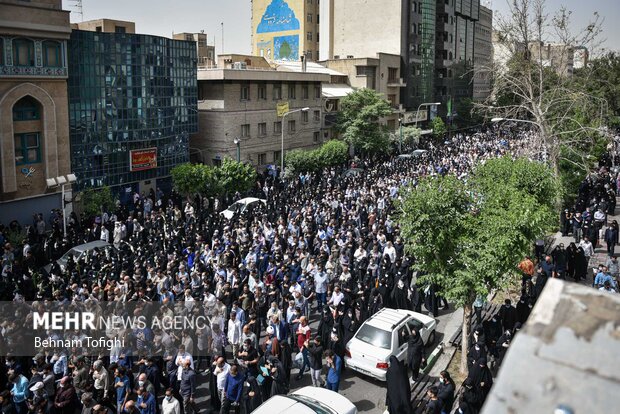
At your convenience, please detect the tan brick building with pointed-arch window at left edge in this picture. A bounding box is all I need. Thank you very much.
[0,0,71,224]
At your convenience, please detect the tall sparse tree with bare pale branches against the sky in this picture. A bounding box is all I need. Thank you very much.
[477,0,602,185]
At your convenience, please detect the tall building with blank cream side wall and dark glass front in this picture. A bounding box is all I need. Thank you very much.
[320,0,480,112]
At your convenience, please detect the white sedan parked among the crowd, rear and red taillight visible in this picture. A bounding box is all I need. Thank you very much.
[344,308,437,381]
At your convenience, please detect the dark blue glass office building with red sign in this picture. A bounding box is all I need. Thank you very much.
[68,30,198,190]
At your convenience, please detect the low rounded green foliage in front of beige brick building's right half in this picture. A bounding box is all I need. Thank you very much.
[284,140,349,172]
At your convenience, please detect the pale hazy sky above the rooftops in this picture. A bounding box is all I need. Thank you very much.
[63,0,620,53]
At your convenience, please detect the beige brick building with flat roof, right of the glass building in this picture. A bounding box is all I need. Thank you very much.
[191,57,329,167]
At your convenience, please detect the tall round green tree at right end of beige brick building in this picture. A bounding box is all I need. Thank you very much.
[336,88,392,154]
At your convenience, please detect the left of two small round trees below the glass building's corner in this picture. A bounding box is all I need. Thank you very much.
[170,163,220,196]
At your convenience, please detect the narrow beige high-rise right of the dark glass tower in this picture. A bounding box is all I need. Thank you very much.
[473,6,493,101]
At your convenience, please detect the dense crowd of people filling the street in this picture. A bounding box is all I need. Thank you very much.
[0,129,618,414]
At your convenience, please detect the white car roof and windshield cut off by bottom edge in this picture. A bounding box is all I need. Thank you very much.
[252,387,357,414]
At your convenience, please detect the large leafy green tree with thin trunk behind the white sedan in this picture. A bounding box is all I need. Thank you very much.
[398,158,559,372]
